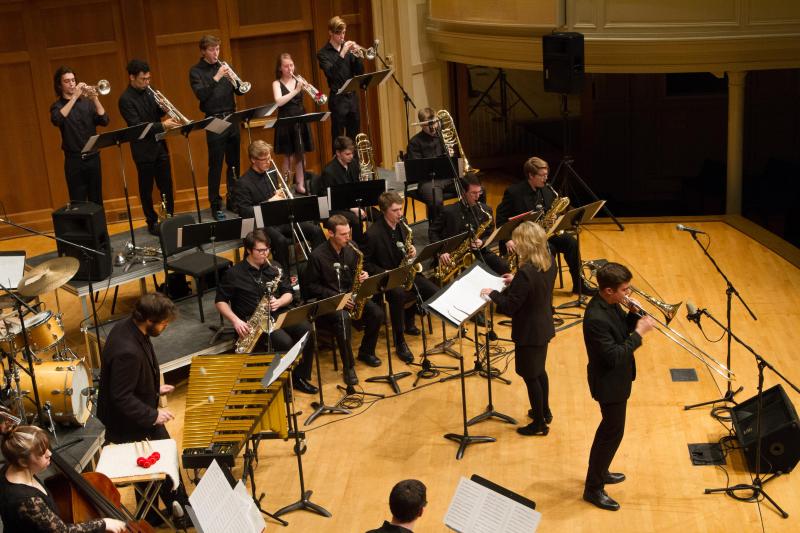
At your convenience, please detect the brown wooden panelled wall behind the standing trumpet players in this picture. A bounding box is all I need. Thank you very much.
[0,0,380,238]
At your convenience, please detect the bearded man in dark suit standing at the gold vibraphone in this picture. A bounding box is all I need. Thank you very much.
[97,292,189,525]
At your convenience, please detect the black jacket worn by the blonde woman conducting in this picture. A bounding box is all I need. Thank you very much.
[489,262,556,346]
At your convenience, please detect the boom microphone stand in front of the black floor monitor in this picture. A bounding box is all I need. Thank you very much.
[698,309,800,518]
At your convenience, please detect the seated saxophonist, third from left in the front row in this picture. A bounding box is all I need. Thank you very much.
[364,191,438,363]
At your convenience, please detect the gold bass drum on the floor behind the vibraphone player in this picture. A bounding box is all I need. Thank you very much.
[12,359,92,425]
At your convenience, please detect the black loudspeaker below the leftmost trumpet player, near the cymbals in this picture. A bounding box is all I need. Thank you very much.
[53,202,113,281]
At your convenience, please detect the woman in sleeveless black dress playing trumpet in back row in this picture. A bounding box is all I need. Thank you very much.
[272,53,314,194]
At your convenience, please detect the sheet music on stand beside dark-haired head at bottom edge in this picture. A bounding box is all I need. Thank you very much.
[444,477,542,533]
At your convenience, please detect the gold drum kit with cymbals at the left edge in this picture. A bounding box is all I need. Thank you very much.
[0,256,93,430]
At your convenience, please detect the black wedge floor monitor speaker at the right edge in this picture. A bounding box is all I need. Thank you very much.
[731,385,800,474]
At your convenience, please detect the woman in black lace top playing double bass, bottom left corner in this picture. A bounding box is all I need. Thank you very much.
[0,426,126,533]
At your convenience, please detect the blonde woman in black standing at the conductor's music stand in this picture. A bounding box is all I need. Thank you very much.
[481,222,556,436]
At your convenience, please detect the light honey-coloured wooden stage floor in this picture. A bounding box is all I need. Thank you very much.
[0,206,800,533]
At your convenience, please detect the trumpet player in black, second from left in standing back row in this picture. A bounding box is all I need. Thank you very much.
[119,59,181,235]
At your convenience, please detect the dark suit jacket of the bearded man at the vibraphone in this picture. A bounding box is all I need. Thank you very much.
[97,318,161,442]
